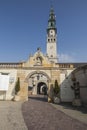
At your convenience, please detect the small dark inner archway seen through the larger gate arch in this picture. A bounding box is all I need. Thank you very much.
[37,82,47,95]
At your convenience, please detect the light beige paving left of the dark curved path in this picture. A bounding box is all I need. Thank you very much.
[0,101,27,130]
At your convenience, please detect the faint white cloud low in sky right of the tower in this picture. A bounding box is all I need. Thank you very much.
[58,53,75,62]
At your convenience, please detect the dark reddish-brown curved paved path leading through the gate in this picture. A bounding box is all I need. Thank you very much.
[22,96,87,130]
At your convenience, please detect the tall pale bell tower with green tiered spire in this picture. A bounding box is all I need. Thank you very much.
[47,7,58,63]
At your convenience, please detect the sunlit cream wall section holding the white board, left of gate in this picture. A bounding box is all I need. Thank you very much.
[0,69,17,100]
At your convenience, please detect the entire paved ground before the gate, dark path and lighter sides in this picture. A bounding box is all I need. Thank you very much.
[0,96,87,130]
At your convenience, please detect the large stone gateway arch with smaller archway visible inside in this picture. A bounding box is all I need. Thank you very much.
[26,71,50,95]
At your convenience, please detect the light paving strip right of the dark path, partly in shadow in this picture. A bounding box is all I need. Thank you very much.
[51,103,87,124]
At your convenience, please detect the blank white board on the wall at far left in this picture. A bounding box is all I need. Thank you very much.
[0,74,9,91]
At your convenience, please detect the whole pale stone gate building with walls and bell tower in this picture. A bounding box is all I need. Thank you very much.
[0,8,86,102]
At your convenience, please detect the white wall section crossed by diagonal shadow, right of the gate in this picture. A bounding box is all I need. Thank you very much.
[60,70,74,102]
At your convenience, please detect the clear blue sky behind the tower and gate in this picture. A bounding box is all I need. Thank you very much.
[0,0,87,62]
